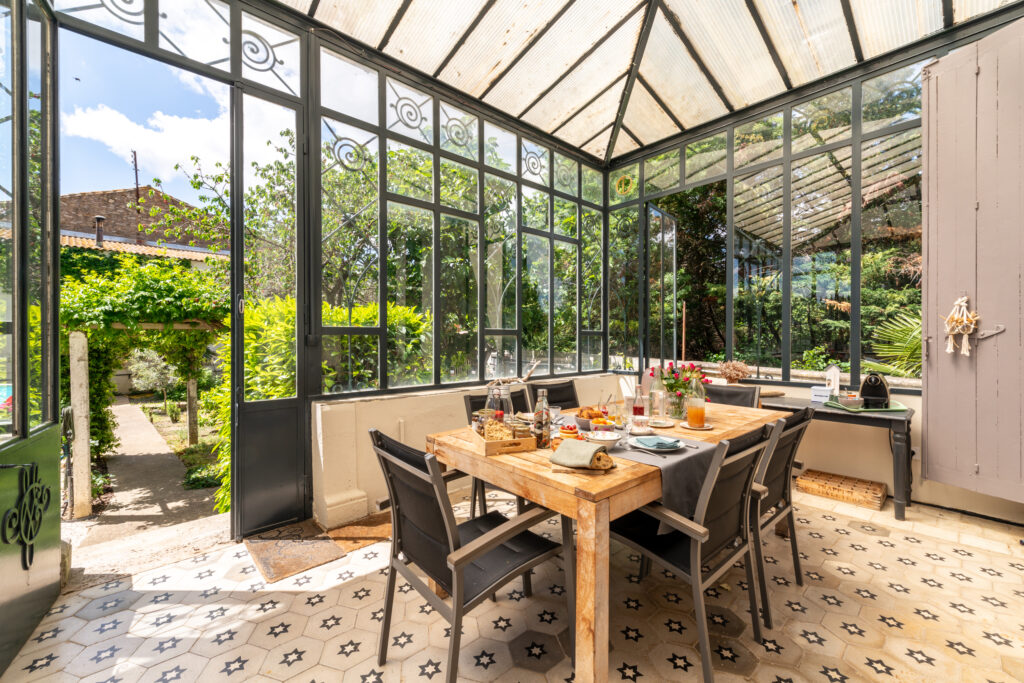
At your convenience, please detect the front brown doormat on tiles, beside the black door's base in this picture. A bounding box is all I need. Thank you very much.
[246,519,345,584]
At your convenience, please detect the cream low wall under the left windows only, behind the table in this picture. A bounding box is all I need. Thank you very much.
[312,375,618,528]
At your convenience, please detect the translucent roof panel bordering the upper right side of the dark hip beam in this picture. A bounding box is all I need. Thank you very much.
[640,10,728,128]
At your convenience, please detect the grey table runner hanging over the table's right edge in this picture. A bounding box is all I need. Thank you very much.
[611,438,716,533]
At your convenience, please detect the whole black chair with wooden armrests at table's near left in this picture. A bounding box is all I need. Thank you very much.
[370,429,575,683]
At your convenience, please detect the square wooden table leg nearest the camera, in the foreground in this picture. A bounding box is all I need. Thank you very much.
[575,500,609,682]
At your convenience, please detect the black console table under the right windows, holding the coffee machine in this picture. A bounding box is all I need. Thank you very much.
[761,396,913,520]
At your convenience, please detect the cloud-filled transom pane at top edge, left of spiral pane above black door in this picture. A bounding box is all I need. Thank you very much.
[158,0,231,71]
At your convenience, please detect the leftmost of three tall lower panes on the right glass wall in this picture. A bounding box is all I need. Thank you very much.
[732,166,784,379]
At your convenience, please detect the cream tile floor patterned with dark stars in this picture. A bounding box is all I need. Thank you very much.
[2,497,1024,683]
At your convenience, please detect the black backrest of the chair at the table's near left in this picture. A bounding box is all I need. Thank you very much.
[370,429,459,588]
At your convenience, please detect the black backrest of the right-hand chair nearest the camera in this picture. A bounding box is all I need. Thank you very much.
[693,420,782,558]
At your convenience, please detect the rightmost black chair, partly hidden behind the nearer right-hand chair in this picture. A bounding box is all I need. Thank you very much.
[751,408,814,629]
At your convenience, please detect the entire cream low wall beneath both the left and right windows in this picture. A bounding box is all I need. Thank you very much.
[312,375,1024,528]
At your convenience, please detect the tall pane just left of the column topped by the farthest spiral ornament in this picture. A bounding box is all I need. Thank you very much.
[483,174,517,327]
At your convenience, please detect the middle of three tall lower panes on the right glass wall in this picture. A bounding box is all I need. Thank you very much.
[791,147,851,379]
